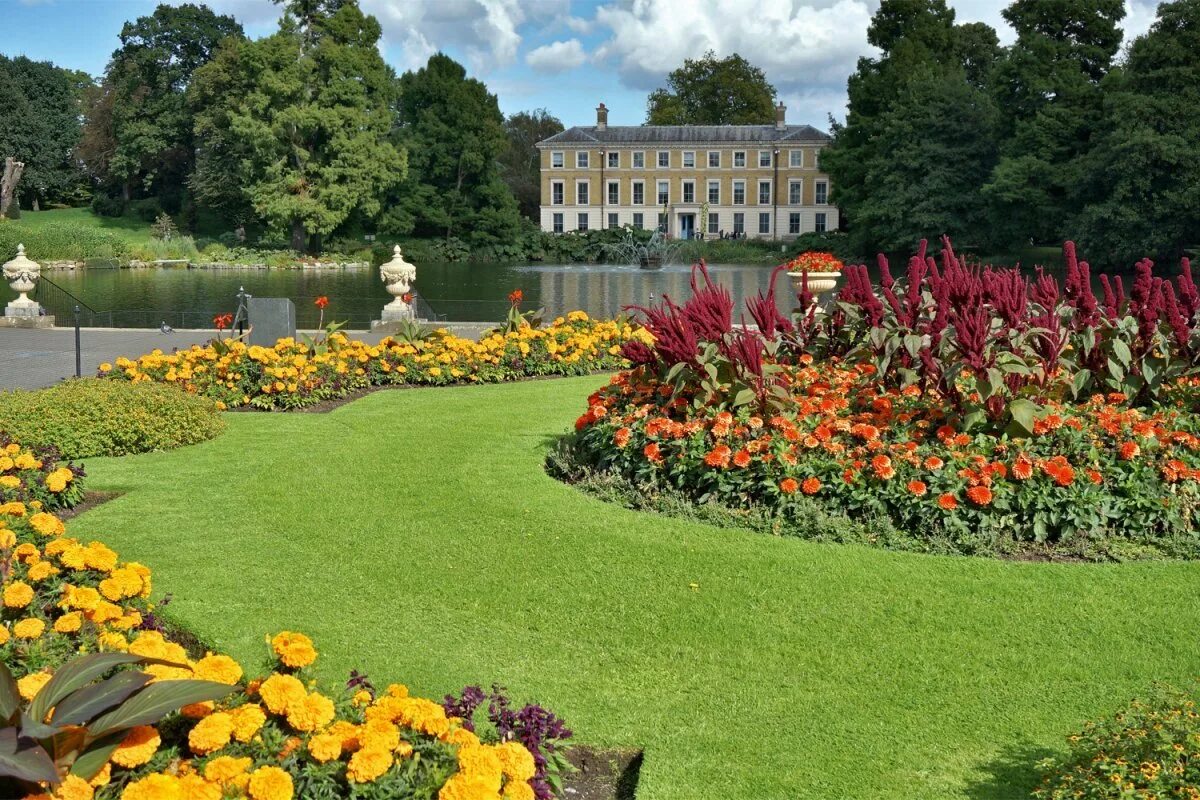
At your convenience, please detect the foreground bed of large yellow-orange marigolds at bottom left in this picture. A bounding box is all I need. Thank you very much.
[0,501,570,800]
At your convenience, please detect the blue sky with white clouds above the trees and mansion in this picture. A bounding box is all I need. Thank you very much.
[0,0,1157,130]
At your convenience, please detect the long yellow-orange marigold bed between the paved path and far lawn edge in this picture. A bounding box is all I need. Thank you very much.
[100,312,652,409]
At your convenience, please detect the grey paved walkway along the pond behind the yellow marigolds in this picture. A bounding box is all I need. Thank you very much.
[0,323,493,390]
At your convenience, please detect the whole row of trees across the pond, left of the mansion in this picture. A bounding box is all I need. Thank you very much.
[0,0,563,251]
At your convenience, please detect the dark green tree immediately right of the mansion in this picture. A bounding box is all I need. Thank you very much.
[821,0,997,252]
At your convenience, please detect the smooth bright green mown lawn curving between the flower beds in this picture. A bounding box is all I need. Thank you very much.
[70,378,1200,800]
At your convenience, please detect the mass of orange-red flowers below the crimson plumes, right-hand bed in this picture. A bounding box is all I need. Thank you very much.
[574,360,1200,558]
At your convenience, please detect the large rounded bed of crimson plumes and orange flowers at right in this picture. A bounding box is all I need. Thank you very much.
[570,242,1200,558]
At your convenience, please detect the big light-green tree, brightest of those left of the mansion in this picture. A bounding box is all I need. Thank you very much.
[192,0,406,251]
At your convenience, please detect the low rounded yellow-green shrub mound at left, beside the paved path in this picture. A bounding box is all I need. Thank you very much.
[0,378,224,458]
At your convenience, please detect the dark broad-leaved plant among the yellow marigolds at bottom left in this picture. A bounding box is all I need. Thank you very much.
[0,652,234,796]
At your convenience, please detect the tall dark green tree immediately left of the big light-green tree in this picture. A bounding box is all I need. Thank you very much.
[80,4,242,212]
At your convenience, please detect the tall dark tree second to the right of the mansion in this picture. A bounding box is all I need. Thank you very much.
[983,0,1124,246]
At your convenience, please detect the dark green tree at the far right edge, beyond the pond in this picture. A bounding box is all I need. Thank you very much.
[1079,0,1200,266]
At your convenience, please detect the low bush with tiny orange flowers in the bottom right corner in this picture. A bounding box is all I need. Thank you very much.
[1033,686,1200,800]
